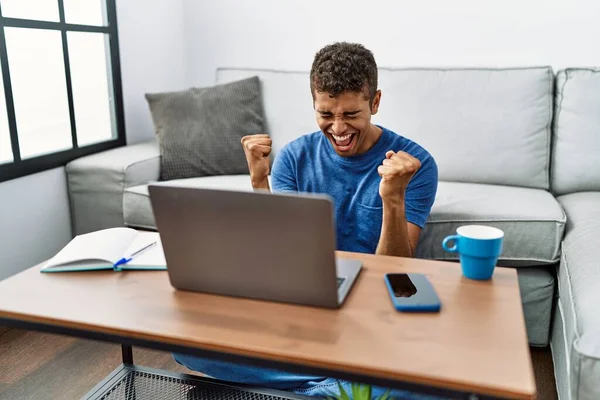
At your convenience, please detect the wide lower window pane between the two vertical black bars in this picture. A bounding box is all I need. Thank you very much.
[5,28,72,158]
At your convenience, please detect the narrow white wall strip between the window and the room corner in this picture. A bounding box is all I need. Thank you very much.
[117,0,186,144]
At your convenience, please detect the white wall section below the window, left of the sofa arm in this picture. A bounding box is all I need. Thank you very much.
[0,167,71,280]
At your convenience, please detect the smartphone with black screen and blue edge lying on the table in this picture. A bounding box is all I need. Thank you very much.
[385,273,442,312]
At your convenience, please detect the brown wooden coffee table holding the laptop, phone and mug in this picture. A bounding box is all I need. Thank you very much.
[0,252,536,399]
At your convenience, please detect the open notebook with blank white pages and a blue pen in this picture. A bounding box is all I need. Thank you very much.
[41,228,167,272]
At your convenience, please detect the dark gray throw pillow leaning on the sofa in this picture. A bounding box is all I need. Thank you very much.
[146,77,266,180]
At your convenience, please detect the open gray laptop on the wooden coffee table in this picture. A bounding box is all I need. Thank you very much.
[148,183,362,308]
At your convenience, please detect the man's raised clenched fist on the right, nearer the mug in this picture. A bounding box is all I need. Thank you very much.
[377,150,421,202]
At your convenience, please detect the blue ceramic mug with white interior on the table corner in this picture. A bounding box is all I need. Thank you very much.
[442,225,504,280]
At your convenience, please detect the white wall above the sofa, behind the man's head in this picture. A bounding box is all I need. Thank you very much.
[184,0,600,85]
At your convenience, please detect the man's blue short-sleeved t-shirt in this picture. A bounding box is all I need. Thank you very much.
[271,127,438,254]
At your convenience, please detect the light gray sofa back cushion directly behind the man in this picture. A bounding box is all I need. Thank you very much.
[217,67,554,189]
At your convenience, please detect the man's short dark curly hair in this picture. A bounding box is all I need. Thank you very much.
[310,42,377,101]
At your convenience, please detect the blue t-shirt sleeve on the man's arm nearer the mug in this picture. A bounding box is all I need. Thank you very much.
[404,155,438,228]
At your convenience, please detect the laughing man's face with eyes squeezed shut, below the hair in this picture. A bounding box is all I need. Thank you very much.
[314,91,381,157]
